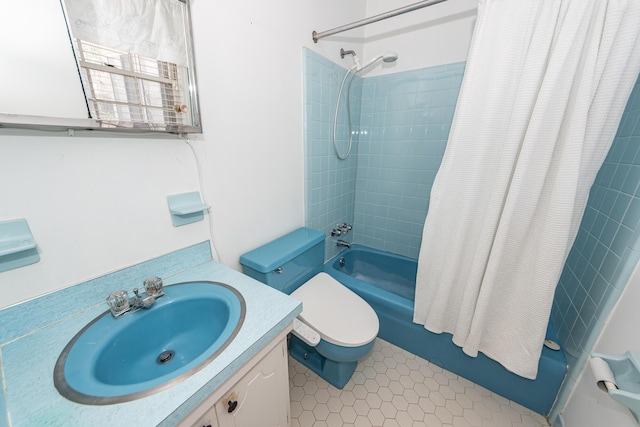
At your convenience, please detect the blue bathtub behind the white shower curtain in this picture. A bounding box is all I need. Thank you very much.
[324,245,567,415]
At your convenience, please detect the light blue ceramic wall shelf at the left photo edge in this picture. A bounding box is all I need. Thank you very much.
[0,219,40,272]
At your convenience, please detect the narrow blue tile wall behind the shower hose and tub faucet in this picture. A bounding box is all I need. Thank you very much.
[303,49,362,259]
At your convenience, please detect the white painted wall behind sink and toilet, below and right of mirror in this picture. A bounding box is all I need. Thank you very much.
[0,0,365,308]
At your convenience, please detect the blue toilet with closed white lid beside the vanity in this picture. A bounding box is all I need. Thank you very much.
[240,227,379,388]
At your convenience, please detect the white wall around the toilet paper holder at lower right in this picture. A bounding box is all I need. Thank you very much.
[562,267,640,427]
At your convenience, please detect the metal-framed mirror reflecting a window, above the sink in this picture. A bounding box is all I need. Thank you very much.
[0,0,201,133]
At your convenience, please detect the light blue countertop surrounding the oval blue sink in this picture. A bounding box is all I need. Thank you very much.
[0,246,302,427]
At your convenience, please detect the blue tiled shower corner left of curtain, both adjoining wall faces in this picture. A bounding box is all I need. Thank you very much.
[303,49,464,259]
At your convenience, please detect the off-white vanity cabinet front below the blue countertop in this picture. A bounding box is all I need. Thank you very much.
[180,333,290,427]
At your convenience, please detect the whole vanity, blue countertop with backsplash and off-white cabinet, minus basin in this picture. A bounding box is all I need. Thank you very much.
[0,242,302,427]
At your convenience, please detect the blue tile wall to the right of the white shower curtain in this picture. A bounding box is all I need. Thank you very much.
[551,74,640,422]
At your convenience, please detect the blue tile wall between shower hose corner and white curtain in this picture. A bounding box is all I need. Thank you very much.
[354,62,465,258]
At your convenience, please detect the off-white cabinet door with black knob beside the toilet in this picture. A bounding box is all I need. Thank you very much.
[215,341,290,427]
